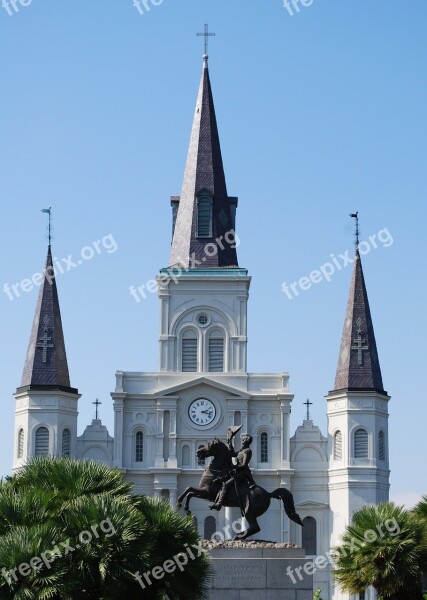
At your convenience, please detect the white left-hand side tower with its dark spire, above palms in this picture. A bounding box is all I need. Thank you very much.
[13,244,80,471]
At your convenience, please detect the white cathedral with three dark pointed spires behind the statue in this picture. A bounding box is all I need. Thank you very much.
[13,55,390,600]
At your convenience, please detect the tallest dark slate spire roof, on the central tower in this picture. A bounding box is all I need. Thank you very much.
[170,55,237,268]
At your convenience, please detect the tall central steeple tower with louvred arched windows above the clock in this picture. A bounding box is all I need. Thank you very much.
[158,55,250,373]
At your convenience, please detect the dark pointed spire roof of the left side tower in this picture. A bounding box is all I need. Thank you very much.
[18,244,77,393]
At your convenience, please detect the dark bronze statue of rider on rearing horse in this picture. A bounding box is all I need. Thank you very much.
[177,426,302,540]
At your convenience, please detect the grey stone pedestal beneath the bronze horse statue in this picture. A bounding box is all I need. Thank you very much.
[208,541,313,600]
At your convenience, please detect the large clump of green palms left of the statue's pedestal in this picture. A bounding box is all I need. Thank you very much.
[0,458,210,600]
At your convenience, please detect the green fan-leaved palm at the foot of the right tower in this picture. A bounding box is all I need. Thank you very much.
[335,502,425,600]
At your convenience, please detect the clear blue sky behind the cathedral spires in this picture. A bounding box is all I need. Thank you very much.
[0,0,427,503]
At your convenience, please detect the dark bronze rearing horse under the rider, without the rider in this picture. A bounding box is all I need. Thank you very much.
[177,438,302,540]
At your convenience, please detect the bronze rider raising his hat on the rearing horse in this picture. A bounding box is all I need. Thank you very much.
[210,427,256,510]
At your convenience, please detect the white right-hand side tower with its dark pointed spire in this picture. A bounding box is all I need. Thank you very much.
[326,249,390,600]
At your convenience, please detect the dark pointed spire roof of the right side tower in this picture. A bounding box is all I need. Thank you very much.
[334,249,386,394]
